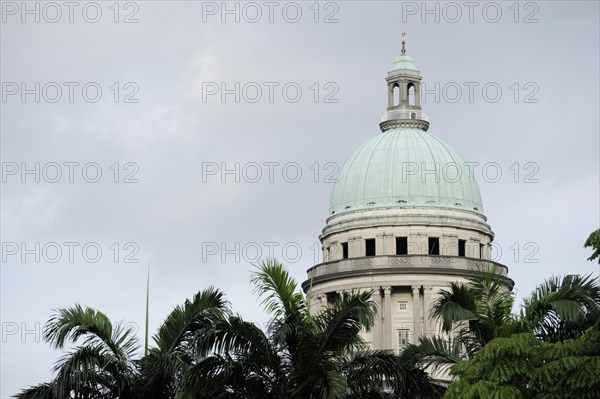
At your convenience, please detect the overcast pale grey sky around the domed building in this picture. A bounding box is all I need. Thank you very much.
[0,1,600,398]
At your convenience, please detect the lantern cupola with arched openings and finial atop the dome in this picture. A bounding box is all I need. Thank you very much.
[379,33,429,132]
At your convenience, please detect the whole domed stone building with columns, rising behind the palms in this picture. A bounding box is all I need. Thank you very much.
[303,41,513,350]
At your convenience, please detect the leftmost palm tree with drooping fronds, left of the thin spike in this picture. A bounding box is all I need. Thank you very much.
[16,304,138,399]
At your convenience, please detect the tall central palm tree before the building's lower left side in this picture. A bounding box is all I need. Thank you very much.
[179,260,435,399]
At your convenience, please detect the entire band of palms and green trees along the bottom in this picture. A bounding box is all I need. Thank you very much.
[15,230,600,399]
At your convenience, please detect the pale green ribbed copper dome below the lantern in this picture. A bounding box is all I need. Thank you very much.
[329,127,485,218]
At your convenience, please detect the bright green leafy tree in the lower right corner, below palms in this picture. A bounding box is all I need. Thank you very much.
[444,328,600,399]
